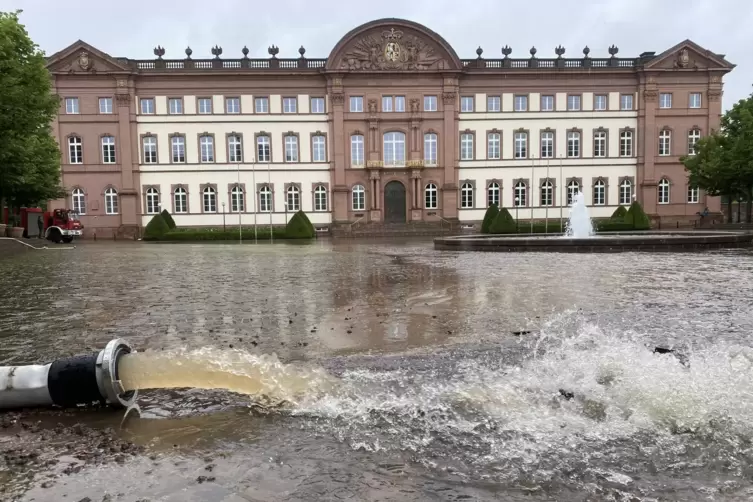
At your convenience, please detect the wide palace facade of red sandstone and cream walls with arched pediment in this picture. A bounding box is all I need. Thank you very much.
[48,19,734,233]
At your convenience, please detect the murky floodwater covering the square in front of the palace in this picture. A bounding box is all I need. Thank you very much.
[0,240,753,502]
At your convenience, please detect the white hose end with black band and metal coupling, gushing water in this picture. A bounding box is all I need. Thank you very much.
[0,338,138,409]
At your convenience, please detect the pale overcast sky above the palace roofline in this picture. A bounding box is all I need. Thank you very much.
[0,0,753,109]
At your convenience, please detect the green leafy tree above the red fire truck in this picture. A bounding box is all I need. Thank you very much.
[0,11,65,220]
